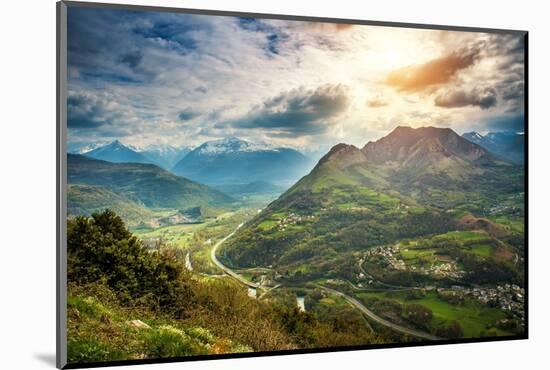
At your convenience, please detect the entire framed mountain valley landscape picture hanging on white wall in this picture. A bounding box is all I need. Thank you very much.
[57,1,528,368]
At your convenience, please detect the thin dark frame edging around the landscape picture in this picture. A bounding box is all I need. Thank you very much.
[56,0,529,369]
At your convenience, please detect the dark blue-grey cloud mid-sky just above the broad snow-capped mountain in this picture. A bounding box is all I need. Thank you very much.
[216,85,350,136]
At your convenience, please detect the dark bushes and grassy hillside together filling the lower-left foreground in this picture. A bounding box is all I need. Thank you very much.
[67,210,385,363]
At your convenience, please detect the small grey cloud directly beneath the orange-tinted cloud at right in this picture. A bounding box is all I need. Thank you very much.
[434,87,497,109]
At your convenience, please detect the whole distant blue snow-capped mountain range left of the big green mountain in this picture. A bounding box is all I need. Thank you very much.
[77,138,314,188]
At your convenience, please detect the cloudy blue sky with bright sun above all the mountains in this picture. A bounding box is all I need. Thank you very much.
[67,7,524,152]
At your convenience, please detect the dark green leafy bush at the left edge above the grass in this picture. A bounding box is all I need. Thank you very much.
[67,210,190,306]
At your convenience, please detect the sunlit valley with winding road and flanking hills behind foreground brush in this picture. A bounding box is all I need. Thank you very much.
[69,128,525,362]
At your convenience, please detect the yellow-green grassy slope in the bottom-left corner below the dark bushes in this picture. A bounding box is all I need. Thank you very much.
[68,295,252,363]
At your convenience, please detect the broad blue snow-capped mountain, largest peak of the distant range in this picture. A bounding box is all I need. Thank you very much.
[172,138,312,185]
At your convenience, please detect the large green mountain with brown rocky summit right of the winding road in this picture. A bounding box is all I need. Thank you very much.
[224,127,524,281]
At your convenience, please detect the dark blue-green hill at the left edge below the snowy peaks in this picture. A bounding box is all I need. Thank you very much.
[67,154,232,209]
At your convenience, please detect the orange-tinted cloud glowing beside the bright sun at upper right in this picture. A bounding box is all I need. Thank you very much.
[385,46,480,91]
